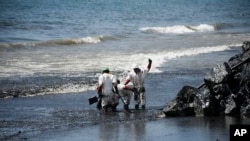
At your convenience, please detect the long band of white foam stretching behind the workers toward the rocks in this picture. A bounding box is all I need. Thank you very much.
[0,45,240,76]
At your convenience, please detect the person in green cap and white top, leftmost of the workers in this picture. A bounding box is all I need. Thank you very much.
[97,68,119,112]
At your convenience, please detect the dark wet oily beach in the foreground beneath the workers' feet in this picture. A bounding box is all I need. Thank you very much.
[0,91,250,141]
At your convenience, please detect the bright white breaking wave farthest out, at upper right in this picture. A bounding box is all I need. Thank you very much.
[139,24,216,34]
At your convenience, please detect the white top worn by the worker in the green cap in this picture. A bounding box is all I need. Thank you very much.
[98,73,116,95]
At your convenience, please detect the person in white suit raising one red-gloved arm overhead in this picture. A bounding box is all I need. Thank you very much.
[125,59,152,109]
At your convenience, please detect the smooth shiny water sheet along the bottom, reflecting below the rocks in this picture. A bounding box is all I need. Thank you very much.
[43,117,249,141]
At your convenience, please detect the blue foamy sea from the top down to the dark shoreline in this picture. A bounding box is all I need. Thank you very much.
[0,0,250,98]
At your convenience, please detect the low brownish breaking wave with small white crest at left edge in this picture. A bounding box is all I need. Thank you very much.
[0,35,109,48]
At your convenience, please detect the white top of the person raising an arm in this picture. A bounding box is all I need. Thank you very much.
[126,69,149,88]
